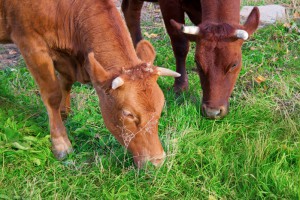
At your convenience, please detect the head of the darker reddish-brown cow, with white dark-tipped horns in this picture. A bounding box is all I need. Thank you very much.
[171,7,259,119]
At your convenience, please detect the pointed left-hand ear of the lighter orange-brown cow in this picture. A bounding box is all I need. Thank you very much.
[88,52,110,82]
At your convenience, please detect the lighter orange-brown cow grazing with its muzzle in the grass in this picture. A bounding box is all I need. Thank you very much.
[0,0,180,167]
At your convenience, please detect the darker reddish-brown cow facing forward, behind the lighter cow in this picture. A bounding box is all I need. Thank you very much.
[122,0,259,119]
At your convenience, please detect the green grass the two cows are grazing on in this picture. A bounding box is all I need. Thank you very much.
[0,22,300,199]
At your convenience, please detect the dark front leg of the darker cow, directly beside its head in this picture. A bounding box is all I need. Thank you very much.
[159,0,189,93]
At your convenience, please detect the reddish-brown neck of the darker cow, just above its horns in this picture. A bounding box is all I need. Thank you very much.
[201,0,241,24]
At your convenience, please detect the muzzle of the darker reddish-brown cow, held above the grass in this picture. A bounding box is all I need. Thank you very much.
[202,103,228,119]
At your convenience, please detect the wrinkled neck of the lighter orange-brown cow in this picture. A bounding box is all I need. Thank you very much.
[75,1,141,71]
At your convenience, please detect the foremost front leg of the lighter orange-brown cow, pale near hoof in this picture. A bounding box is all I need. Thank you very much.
[17,39,72,160]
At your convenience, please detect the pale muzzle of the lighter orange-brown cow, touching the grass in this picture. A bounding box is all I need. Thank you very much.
[133,152,166,168]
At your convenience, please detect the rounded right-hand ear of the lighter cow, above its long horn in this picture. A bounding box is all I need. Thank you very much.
[136,40,156,64]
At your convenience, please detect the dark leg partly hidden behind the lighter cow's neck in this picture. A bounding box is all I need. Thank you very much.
[122,0,144,46]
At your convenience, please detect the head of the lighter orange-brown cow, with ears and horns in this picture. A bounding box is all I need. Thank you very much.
[88,41,180,167]
